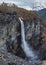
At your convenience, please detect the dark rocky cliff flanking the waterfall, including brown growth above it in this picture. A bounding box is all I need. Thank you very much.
[0,5,46,64]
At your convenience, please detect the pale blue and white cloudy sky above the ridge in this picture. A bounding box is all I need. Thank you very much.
[0,0,46,10]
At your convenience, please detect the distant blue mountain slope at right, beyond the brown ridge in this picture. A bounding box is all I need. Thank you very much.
[35,8,46,28]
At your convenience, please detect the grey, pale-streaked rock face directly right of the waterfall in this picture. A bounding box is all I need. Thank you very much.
[25,19,41,47]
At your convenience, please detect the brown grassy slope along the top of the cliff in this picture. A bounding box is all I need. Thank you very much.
[0,5,39,20]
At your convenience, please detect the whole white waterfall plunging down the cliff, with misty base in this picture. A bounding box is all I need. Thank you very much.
[19,18,40,64]
